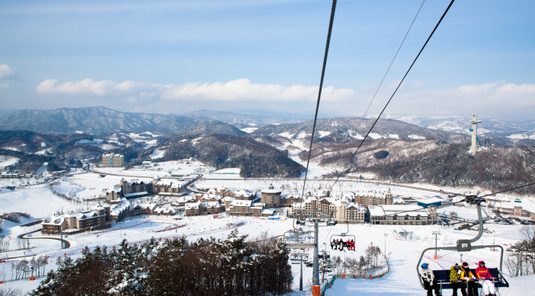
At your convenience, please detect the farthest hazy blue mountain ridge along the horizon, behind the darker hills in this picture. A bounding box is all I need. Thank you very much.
[0,107,535,147]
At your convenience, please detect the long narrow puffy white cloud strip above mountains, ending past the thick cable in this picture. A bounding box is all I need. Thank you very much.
[36,78,354,101]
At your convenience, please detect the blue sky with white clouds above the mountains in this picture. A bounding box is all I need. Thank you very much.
[0,0,535,121]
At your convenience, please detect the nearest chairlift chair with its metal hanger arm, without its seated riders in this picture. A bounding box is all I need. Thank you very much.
[416,196,509,291]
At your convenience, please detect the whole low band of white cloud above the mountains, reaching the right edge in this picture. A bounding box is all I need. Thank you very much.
[36,79,535,121]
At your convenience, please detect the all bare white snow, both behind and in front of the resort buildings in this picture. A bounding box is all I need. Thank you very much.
[0,163,535,296]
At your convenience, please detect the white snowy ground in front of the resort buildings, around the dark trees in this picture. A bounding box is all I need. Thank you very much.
[0,216,535,295]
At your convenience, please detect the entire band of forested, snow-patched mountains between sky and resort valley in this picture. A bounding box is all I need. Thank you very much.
[0,107,535,191]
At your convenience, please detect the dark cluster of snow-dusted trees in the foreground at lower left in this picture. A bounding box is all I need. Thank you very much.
[30,231,292,296]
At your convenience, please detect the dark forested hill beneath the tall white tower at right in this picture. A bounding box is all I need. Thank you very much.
[368,144,535,194]
